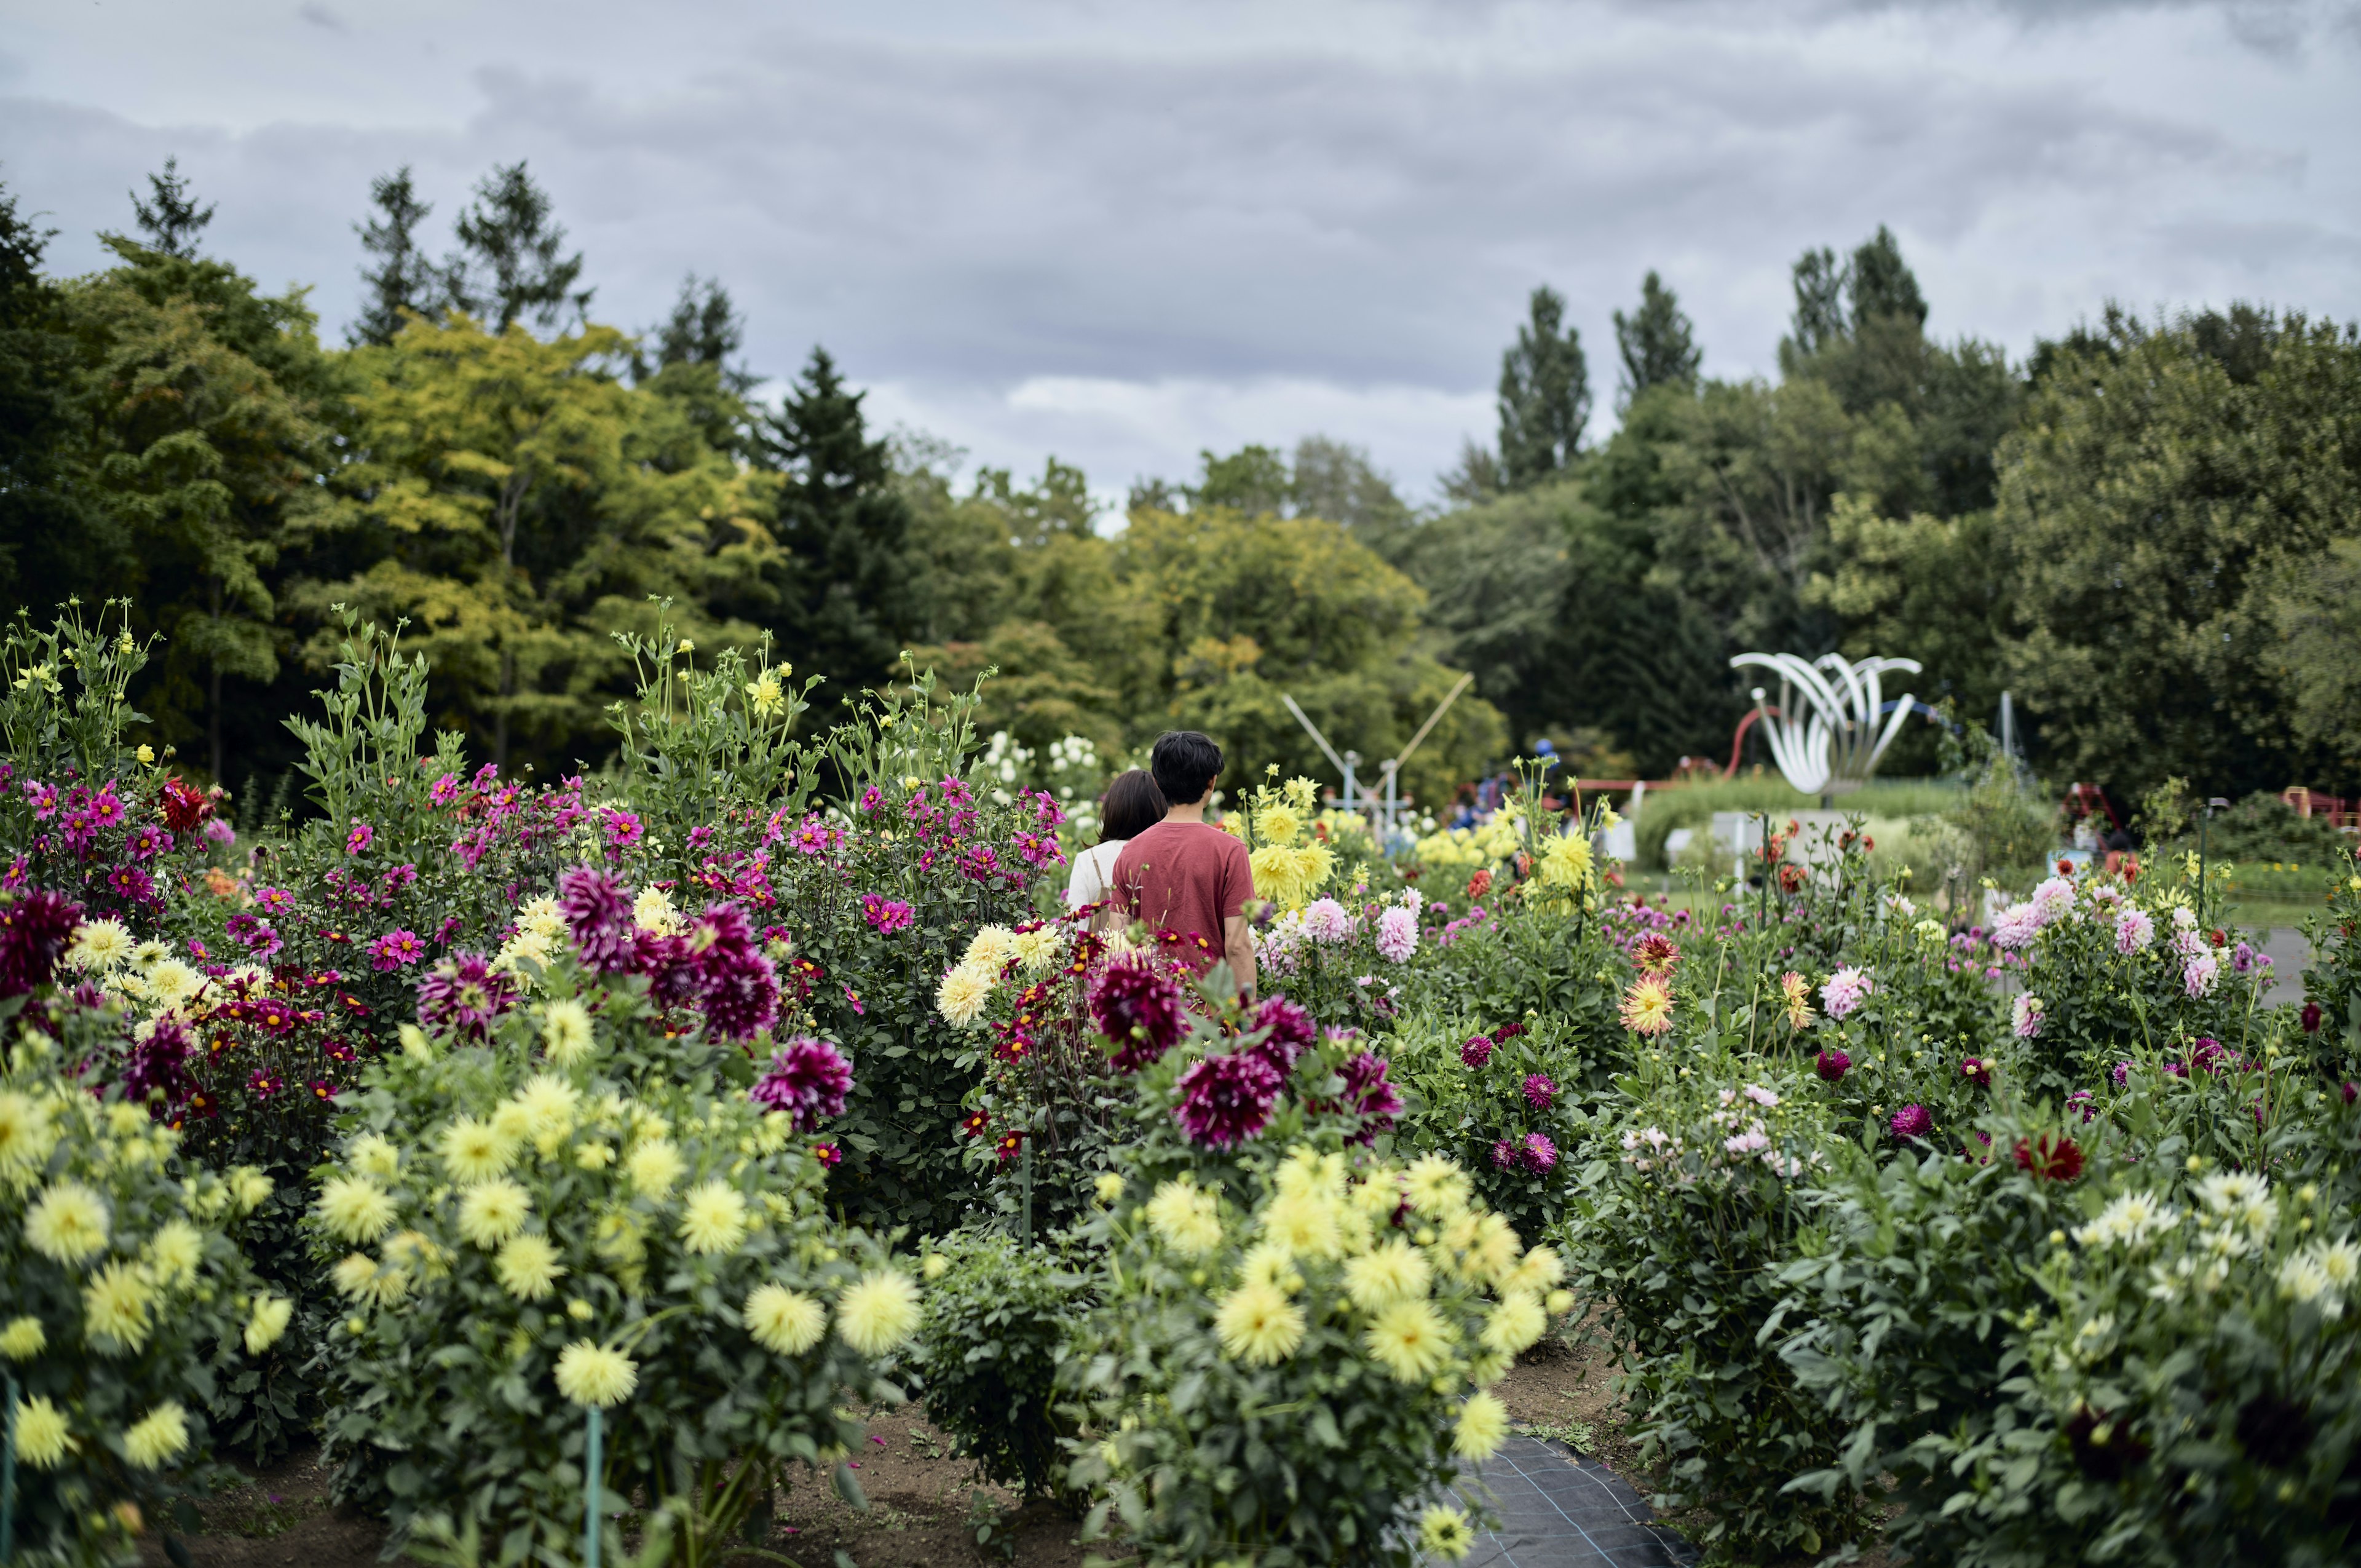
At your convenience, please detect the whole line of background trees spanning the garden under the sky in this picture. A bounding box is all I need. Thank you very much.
[0,163,2361,801]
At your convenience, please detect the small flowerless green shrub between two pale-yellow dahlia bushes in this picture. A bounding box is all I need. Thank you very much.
[911,1228,1093,1497]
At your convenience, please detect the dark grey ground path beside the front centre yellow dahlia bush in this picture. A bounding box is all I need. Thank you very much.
[1435,1438,1698,1568]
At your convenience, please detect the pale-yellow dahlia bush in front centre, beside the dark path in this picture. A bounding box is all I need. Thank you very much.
[1070,1138,1560,1568]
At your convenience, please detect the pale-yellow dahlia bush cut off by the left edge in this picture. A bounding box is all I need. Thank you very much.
[0,1006,290,1563]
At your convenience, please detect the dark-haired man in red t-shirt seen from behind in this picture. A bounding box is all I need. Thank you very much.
[1107,730,1254,997]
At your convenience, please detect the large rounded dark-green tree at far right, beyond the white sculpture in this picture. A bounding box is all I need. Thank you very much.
[1998,312,2361,796]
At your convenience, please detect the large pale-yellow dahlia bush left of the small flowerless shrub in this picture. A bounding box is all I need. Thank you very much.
[309,954,919,1561]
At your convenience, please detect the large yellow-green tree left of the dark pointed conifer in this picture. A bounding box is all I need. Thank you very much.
[309,314,779,762]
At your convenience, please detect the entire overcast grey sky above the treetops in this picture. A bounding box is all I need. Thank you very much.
[0,0,2361,498]
